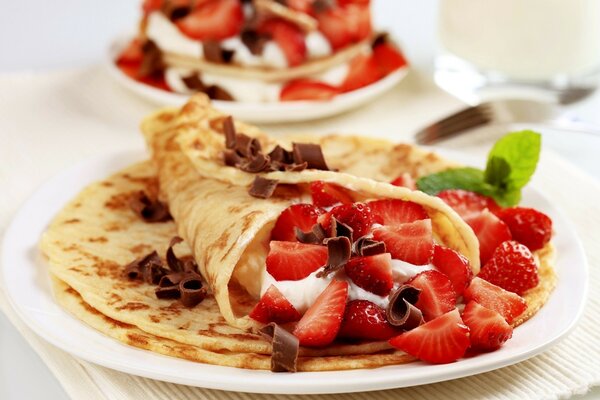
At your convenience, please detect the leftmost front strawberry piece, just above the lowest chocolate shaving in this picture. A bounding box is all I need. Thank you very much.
[249,285,302,324]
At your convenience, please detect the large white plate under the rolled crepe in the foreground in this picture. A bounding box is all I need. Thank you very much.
[0,151,587,394]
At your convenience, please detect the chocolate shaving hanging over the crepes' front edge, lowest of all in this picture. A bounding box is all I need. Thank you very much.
[260,322,300,372]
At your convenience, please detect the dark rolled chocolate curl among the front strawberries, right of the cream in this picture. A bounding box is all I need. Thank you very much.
[385,285,423,330]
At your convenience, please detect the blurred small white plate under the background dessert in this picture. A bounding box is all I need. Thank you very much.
[106,37,408,123]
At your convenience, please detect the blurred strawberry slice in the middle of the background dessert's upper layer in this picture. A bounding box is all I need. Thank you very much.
[258,18,306,67]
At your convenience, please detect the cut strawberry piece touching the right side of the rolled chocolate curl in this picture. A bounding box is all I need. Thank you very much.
[407,270,456,321]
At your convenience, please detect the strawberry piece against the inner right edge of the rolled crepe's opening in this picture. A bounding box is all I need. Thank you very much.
[431,244,473,296]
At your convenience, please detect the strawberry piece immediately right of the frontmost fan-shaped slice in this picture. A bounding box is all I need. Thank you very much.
[462,301,512,350]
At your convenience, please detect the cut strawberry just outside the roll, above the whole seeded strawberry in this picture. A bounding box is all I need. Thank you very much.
[467,210,512,265]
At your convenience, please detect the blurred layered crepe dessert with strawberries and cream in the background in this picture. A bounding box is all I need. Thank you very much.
[115,0,406,103]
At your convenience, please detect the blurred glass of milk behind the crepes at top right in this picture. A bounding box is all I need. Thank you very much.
[435,0,600,102]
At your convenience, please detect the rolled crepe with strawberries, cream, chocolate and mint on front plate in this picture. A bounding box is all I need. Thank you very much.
[41,95,556,371]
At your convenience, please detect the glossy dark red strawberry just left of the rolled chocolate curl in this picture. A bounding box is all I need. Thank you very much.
[338,300,399,340]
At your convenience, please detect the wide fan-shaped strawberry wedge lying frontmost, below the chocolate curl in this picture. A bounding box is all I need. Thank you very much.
[389,309,470,364]
